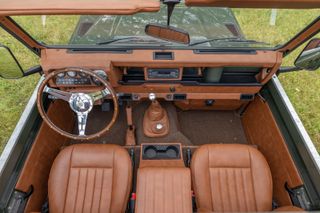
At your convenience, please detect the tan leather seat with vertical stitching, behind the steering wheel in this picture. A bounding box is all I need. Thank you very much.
[48,144,132,213]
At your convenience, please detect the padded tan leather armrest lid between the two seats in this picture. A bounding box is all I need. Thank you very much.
[135,167,192,213]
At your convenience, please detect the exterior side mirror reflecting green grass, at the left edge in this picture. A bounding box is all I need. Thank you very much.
[0,45,24,79]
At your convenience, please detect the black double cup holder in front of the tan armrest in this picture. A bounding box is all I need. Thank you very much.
[142,144,180,160]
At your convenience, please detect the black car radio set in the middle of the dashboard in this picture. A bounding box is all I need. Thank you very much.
[147,68,180,80]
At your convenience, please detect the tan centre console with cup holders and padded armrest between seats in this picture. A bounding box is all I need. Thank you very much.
[135,143,192,213]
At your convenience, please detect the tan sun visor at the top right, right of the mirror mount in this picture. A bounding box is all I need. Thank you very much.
[185,0,320,9]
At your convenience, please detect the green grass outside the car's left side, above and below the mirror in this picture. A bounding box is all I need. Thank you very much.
[0,27,39,148]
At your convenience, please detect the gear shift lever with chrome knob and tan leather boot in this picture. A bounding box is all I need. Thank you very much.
[143,93,169,137]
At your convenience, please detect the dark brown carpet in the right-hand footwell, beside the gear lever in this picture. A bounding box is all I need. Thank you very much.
[178,111,247,145]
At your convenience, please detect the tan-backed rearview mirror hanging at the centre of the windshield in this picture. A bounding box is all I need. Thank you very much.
[145,24,190,44]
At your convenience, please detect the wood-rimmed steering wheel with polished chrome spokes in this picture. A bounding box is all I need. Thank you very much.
[37,68,119,140]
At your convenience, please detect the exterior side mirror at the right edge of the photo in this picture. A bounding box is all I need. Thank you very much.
[294,38,320,71]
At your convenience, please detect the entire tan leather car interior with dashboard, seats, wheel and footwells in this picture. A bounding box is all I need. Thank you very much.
[10,49,303,212]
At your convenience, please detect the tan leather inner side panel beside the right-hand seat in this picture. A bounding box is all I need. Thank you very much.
[242,98,303,206]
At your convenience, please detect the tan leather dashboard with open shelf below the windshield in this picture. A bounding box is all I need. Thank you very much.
[41,49,282,100]
